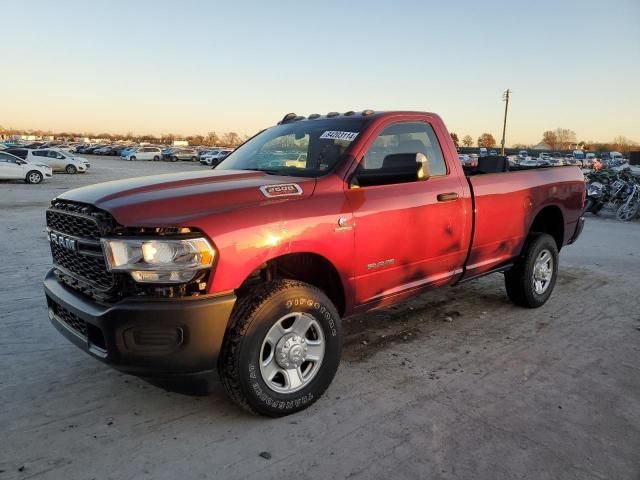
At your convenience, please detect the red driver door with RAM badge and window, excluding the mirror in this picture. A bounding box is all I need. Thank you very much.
[346,121,470,306]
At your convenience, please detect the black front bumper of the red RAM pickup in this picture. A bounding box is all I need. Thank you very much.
[44,269,236,376]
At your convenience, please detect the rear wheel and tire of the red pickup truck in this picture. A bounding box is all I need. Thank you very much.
[504,233,558,308]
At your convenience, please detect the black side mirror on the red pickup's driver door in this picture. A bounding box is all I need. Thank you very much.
[351,153,430,188]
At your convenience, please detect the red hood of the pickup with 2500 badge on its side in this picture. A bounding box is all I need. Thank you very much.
[58,170,316,227]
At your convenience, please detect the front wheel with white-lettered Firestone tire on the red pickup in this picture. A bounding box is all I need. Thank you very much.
[218,280,342,417]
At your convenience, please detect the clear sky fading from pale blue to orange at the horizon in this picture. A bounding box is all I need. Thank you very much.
[0,0,640,145]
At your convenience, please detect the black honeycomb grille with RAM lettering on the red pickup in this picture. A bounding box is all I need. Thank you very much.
[47,201,115,296]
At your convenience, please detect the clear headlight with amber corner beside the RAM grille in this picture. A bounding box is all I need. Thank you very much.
[102,238,215,283]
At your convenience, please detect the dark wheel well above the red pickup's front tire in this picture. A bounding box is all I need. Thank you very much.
[239,253,345,315]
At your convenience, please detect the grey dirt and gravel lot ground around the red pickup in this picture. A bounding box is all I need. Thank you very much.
[0,158,640,480]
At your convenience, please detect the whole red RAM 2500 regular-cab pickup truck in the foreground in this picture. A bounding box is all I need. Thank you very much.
[44,110,585,416]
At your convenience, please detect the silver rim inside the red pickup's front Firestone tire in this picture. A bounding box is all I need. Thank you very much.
[260,312,325,393]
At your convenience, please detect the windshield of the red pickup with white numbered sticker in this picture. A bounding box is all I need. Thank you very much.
[216,117,370,177]
